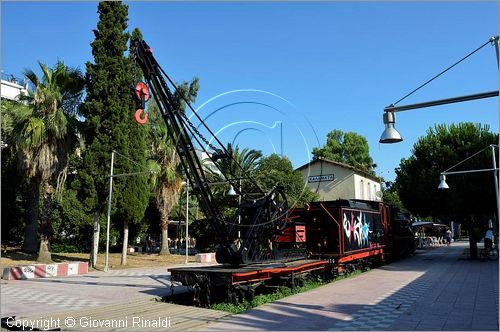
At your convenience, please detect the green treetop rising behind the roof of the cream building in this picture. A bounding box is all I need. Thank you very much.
[313,129,377,174]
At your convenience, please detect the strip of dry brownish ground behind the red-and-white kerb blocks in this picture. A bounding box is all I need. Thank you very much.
[0,247,194,270]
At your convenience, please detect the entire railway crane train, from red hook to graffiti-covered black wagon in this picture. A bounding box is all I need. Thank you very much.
[131,39,415,306]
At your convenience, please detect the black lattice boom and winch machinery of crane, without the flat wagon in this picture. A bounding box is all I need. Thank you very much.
[132,40,288,266]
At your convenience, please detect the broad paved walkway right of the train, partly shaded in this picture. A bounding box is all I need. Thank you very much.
[204,241,499,331]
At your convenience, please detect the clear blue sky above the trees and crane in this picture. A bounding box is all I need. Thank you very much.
[1,1,499,180]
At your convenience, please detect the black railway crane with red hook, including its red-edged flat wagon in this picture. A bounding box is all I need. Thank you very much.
[131,39,326,305]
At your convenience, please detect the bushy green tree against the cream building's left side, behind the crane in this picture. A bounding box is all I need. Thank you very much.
[256,154,317,207]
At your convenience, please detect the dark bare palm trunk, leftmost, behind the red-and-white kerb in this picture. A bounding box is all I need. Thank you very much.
[22,177,40,253]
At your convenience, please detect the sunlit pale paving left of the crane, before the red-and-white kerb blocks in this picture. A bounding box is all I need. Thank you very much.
[0,263,206,317]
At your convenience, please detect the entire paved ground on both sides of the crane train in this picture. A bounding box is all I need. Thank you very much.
[1,242,499,331]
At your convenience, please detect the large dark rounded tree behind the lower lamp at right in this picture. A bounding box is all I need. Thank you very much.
[396,123,498,257]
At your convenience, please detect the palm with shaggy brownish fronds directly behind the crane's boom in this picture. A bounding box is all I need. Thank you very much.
[148,78,199,255]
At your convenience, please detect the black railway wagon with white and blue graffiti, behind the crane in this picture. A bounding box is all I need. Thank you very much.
[290,200,415,268]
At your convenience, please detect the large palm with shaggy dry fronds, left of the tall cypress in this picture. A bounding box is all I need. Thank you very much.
[13,61,84,261]
